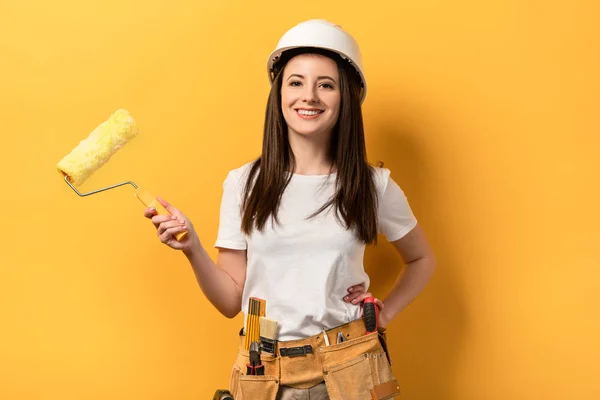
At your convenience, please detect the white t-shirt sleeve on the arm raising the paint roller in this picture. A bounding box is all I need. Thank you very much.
[215,171,247,250]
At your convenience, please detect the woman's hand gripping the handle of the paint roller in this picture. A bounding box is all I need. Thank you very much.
[144,197,199,250]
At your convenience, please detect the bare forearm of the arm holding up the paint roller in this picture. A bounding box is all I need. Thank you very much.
[183,245,242,318]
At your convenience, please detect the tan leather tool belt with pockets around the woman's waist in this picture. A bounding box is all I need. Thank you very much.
[229,319,400,400]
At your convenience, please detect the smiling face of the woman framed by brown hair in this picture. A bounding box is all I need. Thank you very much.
[281,54,341,141]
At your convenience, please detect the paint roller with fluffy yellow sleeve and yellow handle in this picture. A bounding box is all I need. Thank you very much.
[56,108,187,240]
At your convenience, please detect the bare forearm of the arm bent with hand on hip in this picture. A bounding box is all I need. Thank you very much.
[380,257,435,326]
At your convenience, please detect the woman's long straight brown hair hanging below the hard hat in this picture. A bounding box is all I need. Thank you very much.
[242,48,377,244]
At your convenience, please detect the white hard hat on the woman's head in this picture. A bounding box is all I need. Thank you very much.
[267,19,367,103]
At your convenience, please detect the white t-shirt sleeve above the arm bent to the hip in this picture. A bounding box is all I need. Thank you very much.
[378,168,417,242]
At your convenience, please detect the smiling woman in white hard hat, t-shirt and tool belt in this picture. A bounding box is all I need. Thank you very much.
[144,20,434,400]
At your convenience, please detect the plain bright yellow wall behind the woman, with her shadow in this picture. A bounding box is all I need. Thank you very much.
[0,0,600,400]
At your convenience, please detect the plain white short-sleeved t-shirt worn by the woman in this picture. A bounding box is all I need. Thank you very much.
[215,163,417,340]
